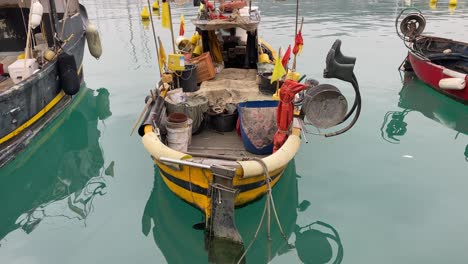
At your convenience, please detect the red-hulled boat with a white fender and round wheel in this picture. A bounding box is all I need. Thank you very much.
[395,8,468,104]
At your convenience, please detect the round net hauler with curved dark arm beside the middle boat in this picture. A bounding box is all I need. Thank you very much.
[301,39,361,137]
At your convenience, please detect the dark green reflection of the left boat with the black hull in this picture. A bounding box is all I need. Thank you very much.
[0,86,113,241]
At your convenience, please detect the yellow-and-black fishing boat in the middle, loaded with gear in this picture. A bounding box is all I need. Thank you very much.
[137,2,361,243]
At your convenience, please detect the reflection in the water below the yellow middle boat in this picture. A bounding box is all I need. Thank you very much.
[142,160,343,264]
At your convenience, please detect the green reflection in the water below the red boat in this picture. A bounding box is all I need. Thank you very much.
[381,72,468,160]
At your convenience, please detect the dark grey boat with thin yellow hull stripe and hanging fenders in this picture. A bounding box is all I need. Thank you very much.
[0,0,102,167]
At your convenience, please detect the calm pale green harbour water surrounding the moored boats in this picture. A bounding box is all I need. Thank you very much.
[0,0,468,264]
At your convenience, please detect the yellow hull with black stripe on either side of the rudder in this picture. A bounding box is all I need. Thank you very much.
[155,161,285,219]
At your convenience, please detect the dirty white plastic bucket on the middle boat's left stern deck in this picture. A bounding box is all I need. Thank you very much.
[166,119,192,152]
